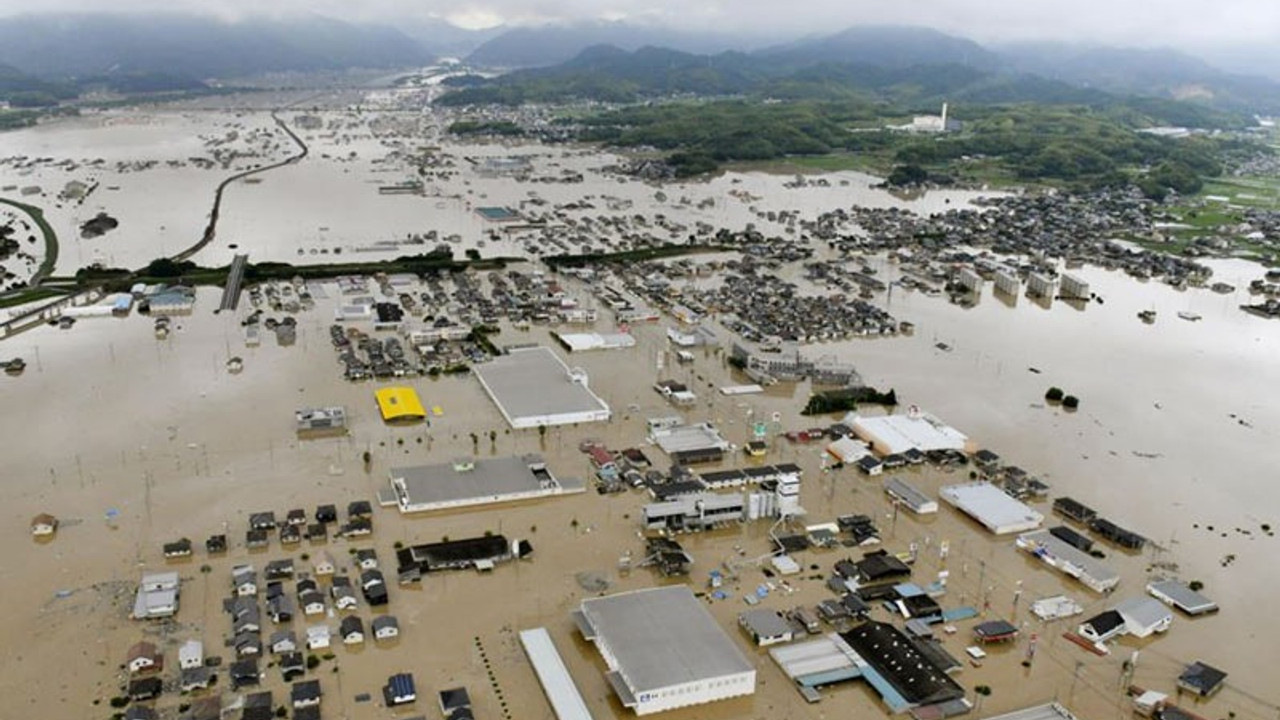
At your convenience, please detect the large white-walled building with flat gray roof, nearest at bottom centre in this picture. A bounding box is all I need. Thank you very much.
[572,585,755,715]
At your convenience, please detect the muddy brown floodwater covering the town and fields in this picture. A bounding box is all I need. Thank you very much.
[0,106,1280,720]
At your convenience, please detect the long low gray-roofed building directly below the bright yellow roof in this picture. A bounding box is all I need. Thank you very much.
[390,455,584,509]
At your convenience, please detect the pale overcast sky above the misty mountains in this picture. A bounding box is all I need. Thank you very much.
[0,0,1280,47]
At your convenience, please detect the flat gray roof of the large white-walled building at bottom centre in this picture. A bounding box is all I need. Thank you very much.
[575,585,755,694]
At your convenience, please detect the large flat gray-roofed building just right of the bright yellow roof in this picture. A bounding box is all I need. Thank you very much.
[475,347,609,428]
